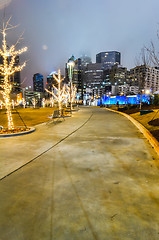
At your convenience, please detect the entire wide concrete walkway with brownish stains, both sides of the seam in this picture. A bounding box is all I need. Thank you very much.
[0,107,159,240]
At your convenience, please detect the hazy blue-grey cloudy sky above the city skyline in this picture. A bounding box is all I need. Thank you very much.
[0,0,159,85]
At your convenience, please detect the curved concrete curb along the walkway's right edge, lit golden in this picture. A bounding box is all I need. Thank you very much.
[106,108,159,156]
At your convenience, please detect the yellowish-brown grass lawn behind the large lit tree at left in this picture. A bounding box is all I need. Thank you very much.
[0,107,57,128]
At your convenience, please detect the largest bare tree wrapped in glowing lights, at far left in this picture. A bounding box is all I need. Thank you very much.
[0,18,27,130]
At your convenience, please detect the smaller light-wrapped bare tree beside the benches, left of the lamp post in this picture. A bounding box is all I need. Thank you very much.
[45,70,66,116]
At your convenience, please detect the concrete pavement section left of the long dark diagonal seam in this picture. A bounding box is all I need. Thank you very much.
[0,109,91,178]
